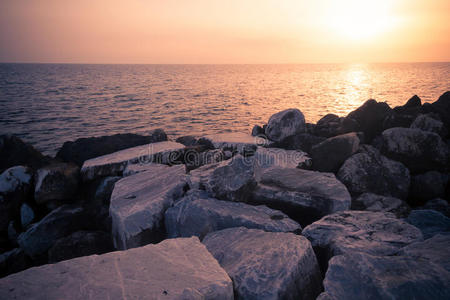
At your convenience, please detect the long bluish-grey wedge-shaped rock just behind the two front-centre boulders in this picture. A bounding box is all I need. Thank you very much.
[165,190,301,239]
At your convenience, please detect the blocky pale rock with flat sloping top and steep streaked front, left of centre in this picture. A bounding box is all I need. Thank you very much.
[109,164,186,250]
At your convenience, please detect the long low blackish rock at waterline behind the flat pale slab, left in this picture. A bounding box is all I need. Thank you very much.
[56,129,167,166]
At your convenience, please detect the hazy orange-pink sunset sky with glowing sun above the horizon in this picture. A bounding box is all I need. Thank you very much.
[0,0,450,64]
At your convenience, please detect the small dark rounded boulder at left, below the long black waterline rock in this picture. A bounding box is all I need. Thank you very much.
[34,163,80,204]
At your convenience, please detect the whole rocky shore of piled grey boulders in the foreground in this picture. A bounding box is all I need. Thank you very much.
[0,92,450,299]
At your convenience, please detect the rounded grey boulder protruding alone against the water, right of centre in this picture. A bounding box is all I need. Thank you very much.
[265,108,305,142]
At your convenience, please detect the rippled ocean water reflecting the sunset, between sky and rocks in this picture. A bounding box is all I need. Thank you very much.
[0,63,450,155]
